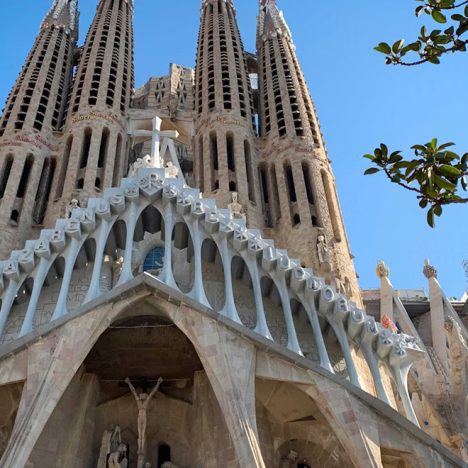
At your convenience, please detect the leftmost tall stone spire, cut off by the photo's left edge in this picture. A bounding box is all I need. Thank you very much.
[0,0,78,256]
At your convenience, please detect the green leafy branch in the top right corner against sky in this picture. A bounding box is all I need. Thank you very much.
[375,0,468,66]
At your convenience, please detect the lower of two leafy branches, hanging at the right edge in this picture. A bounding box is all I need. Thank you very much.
[364,139,468,227]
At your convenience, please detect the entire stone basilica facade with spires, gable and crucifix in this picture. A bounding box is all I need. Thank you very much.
[0,0,468,468]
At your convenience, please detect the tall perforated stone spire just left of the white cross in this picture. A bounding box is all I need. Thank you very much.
[46,0,134,222]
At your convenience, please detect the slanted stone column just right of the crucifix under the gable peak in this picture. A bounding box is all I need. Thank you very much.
[171,306,266,468]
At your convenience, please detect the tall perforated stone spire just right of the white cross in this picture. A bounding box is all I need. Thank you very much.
[195,0,260,224]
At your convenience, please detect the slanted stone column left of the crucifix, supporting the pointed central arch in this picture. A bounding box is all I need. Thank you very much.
[0,292,147,468]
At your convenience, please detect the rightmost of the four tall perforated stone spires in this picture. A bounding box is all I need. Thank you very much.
[257,0,359,300]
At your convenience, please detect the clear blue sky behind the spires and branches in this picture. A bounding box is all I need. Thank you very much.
[0,0,468,297]
